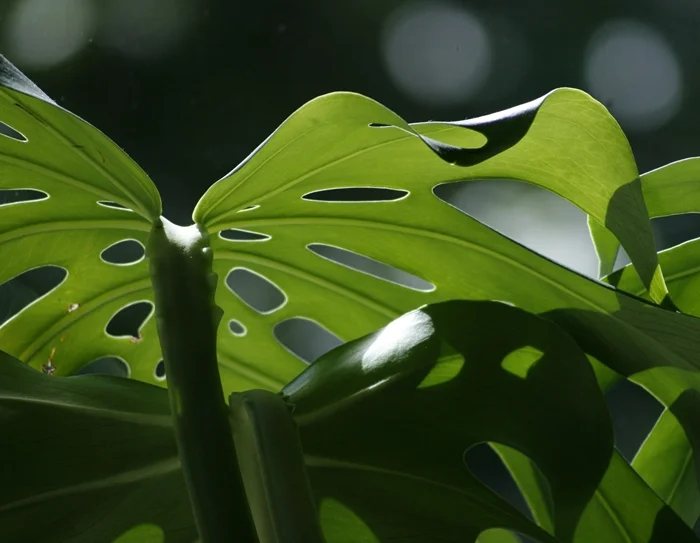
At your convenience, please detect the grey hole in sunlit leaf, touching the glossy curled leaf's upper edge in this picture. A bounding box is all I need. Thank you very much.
[273,317,343,364]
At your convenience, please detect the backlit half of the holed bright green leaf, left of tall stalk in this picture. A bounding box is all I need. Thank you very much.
[0,57,161,382]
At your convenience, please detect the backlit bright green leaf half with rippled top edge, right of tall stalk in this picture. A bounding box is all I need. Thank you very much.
[194,89,665,394]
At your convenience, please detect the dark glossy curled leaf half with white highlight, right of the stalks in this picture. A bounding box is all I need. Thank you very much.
[284,302,695,543]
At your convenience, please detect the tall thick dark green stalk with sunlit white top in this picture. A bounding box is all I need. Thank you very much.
[147,218,257,543]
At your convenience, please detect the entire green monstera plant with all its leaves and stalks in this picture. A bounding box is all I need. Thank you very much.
[0,57,700,543]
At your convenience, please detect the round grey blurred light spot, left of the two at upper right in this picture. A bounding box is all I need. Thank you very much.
[382,1,492,105]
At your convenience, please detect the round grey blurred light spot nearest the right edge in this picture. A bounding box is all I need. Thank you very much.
[585,20,683,132]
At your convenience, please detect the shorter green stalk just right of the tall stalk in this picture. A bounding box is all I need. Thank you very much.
[229,390,324,543]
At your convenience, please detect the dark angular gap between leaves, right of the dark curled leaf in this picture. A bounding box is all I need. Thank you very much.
[605,379,664,462]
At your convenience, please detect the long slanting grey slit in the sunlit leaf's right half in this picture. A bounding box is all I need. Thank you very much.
[306,243,435,292]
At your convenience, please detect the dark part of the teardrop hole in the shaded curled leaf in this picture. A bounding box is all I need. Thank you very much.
[463,443,549,520]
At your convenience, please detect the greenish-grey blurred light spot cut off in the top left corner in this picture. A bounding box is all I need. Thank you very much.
[5,0,95,69]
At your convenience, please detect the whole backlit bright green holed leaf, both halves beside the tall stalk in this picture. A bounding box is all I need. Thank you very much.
[0,55,666,398]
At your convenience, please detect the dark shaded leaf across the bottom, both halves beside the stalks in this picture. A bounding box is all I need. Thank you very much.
[0,301,695,543]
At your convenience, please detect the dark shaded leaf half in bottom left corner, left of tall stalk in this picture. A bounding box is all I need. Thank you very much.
[0,353,197,543]
